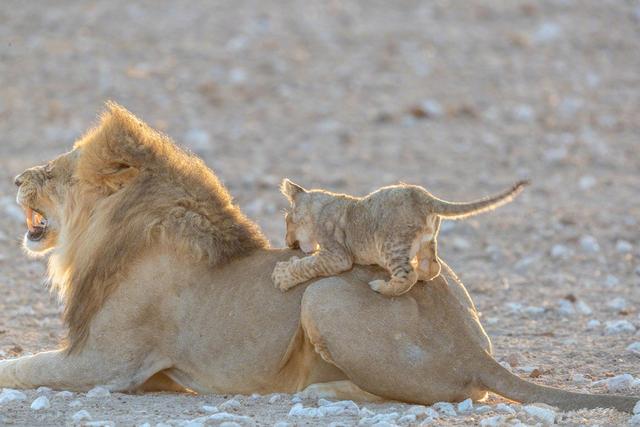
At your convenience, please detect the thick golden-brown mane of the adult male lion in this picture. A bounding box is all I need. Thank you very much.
[31,103,268,352]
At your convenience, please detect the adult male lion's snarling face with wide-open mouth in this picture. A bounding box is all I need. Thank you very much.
[15,151,78,255]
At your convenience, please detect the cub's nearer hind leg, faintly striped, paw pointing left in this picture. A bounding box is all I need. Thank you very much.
[369,237,418,296]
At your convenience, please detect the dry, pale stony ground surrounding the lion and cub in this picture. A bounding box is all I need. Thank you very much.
[0,0,640,426]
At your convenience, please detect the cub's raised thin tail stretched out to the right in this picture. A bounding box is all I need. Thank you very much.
[430,181,529,219]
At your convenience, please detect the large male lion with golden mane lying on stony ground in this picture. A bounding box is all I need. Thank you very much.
[0,104,637,411]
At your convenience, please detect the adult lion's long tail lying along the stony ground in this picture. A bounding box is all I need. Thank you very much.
[478,353,640,412]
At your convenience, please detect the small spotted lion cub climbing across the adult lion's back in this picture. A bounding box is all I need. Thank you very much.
[272,179,528,296]
